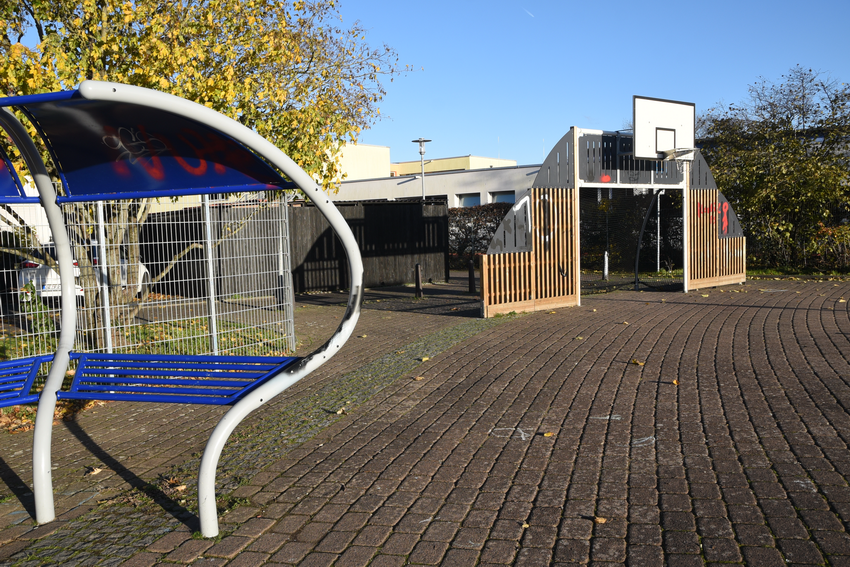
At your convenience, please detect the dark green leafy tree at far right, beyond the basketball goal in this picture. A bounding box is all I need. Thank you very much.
[702,65,850,269]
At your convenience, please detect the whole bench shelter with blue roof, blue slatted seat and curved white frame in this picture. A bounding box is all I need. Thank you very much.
[0,81,363,537]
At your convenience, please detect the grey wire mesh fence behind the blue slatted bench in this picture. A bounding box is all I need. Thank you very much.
[0,191,295,390]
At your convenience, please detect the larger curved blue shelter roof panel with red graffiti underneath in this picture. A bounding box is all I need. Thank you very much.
[0,91,296,202]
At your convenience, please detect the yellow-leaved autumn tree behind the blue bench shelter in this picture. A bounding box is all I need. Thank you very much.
[0,0,402,346]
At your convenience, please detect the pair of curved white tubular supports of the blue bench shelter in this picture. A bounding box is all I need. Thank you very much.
[0,81,363,537]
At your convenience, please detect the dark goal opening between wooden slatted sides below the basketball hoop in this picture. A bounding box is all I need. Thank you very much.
[579,188,684,293]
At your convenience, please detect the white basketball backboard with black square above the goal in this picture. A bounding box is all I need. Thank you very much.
[633,95,696,160]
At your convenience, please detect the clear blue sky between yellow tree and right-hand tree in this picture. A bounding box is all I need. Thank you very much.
[340,0,850,165]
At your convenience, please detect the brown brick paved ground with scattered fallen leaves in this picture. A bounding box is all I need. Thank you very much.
[0,281,850,567]
